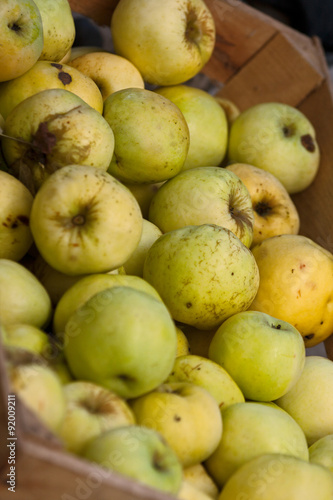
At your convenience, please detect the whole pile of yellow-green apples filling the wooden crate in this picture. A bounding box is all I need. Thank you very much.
[0,0,333,500]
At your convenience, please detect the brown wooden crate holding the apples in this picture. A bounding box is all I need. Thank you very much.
[0,0,333,500]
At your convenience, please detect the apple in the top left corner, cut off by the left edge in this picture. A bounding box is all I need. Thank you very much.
[0,0,43,82]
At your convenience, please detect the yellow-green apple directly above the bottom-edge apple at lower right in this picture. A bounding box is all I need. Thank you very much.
[205,401,309,487]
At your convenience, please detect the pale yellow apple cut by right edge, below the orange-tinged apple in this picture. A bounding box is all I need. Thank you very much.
[275,356,333,446]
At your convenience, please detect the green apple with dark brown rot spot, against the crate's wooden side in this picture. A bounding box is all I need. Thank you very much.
[228,102,320,194]
